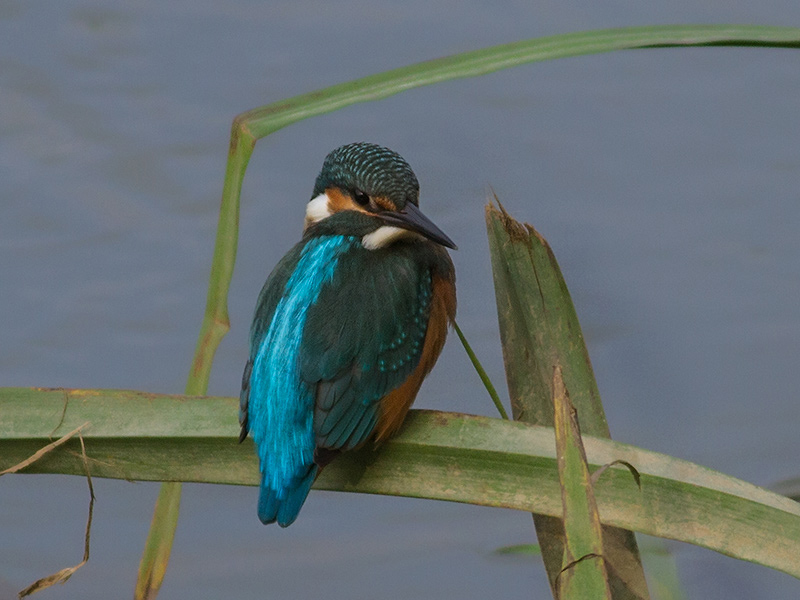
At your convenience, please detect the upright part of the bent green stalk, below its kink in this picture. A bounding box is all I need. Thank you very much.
[134,128,255,600]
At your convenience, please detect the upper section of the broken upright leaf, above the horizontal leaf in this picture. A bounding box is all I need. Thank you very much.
[486,198,609,437]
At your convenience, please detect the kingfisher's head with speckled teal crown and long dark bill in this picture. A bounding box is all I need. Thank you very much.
[306,142,456,250]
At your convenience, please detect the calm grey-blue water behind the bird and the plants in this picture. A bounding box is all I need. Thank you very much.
[0,0,800,600]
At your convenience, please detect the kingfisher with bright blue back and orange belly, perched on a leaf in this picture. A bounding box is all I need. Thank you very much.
[239,142,457,527]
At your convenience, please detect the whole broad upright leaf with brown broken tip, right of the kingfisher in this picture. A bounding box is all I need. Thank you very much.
[486,206,649,600]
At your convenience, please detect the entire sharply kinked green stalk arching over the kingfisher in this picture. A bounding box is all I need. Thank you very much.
[131,25,800,600]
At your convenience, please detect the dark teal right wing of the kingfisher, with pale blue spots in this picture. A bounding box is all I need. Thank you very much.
[300,245,431,450]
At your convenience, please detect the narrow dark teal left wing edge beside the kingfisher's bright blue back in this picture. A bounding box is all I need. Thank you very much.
[239,242,303,442]
